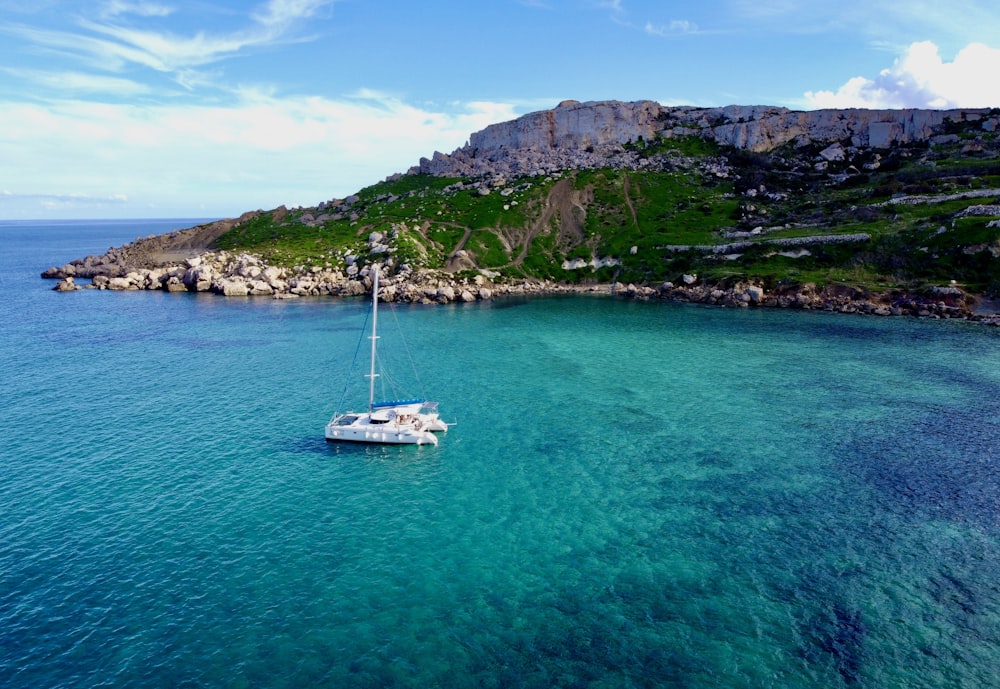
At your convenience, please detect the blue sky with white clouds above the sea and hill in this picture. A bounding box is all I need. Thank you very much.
[0,0,1000,219]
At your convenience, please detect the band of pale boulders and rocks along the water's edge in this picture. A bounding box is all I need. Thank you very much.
[42,249,1000,326]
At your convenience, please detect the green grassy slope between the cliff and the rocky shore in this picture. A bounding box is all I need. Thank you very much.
[217,123,1000,295]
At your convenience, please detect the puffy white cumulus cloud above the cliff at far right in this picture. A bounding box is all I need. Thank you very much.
[805,41,1000,109]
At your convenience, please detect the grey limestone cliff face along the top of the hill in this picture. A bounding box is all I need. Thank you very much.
[411,101,1000,176]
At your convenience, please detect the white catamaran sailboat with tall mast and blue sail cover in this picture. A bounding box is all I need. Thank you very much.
[326,265,448,445]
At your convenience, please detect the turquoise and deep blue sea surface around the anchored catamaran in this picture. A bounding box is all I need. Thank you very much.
[0,220,1000,689]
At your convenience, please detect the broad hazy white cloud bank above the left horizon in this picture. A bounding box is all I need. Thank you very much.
[0,91,516,217]
